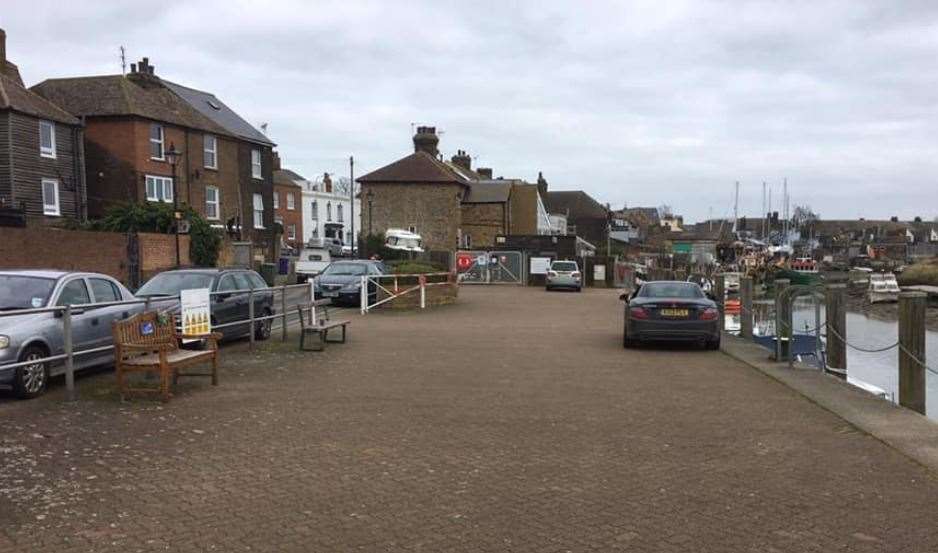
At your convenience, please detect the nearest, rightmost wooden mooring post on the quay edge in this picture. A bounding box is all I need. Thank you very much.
[899,292,928,415]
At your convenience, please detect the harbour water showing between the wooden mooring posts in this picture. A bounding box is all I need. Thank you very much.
[728,298,938,420]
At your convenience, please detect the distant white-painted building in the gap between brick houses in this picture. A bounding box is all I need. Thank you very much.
[299,173,362,247]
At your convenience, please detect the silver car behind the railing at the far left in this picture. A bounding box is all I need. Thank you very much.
[0,271,142,399]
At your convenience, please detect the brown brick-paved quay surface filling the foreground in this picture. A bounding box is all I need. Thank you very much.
[0,287,938,552]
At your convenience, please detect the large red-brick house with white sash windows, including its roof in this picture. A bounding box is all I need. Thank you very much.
[31,58,276,258]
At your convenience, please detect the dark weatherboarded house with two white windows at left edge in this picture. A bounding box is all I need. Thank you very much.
[0,29,86,226]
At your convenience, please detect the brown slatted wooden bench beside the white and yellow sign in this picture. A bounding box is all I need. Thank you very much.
[111,311,221,402]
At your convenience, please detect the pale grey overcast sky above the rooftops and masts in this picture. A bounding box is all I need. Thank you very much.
[0,0,938,220]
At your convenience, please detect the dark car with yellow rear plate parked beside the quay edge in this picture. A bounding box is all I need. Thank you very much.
[620,280,720,349]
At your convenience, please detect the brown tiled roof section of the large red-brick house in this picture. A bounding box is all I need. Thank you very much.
[30,74,230,136]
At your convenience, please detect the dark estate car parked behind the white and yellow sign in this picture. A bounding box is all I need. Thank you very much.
[136,268,274,340]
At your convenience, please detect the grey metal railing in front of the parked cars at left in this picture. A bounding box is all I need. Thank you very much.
[0,281,331,401]
